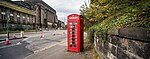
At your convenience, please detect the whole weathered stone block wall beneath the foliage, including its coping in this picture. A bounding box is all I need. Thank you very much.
[94,28,150,59]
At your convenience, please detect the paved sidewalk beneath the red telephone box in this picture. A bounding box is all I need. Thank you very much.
[24,42,92,59]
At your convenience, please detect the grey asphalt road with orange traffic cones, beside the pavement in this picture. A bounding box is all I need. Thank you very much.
[0,30,66,59]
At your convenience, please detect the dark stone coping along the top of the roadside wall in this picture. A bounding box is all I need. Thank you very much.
[107,27,150,42]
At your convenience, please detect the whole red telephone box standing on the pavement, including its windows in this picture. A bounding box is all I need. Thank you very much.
[67,14,84,52]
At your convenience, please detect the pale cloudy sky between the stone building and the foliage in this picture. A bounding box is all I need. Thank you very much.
[12,0,90,23]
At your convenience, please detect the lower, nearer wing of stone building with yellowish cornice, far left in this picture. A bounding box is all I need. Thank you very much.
[0,1,36,30]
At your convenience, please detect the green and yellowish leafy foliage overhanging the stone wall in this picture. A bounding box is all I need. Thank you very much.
[81,0,150,36]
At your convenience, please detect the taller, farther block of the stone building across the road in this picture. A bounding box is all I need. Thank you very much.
[16,0,58,29]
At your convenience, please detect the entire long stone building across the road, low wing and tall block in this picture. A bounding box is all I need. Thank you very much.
[0,0,58,29]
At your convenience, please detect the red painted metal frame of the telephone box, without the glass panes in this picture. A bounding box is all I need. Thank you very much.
[67,14,84,52]
